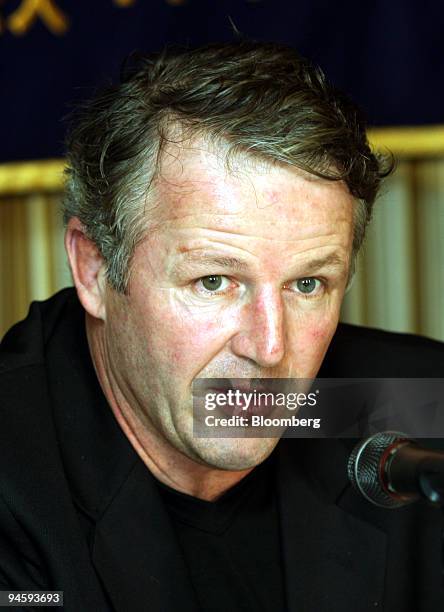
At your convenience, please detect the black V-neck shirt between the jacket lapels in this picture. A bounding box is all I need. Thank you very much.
[158,455,286,612]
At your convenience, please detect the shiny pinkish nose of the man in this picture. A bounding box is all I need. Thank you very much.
[231,286,285,368]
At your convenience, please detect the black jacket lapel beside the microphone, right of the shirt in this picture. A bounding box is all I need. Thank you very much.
[277,440,386,612]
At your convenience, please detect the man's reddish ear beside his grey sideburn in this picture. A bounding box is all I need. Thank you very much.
[65,217,106,321]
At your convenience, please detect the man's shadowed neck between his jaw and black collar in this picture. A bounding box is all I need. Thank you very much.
[86,315,254,501]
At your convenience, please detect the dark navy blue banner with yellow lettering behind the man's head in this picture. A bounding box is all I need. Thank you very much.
[0,0,444,161]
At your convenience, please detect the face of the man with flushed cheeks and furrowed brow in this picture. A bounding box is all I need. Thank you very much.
[105,140,355,470]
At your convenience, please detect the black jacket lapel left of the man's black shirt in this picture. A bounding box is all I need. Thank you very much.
[93,461,198,612]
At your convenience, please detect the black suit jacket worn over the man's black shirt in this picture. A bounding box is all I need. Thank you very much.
[0,290,444,612]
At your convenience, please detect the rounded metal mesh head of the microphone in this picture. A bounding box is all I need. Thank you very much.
[347,431,411,508]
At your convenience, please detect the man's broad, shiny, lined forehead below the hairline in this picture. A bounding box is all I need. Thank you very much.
[151,138,354,238]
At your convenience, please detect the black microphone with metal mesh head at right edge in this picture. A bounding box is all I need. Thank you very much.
[348,431,444,508]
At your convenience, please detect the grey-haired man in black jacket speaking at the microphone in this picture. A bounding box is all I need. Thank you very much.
[0,43,444,612]
